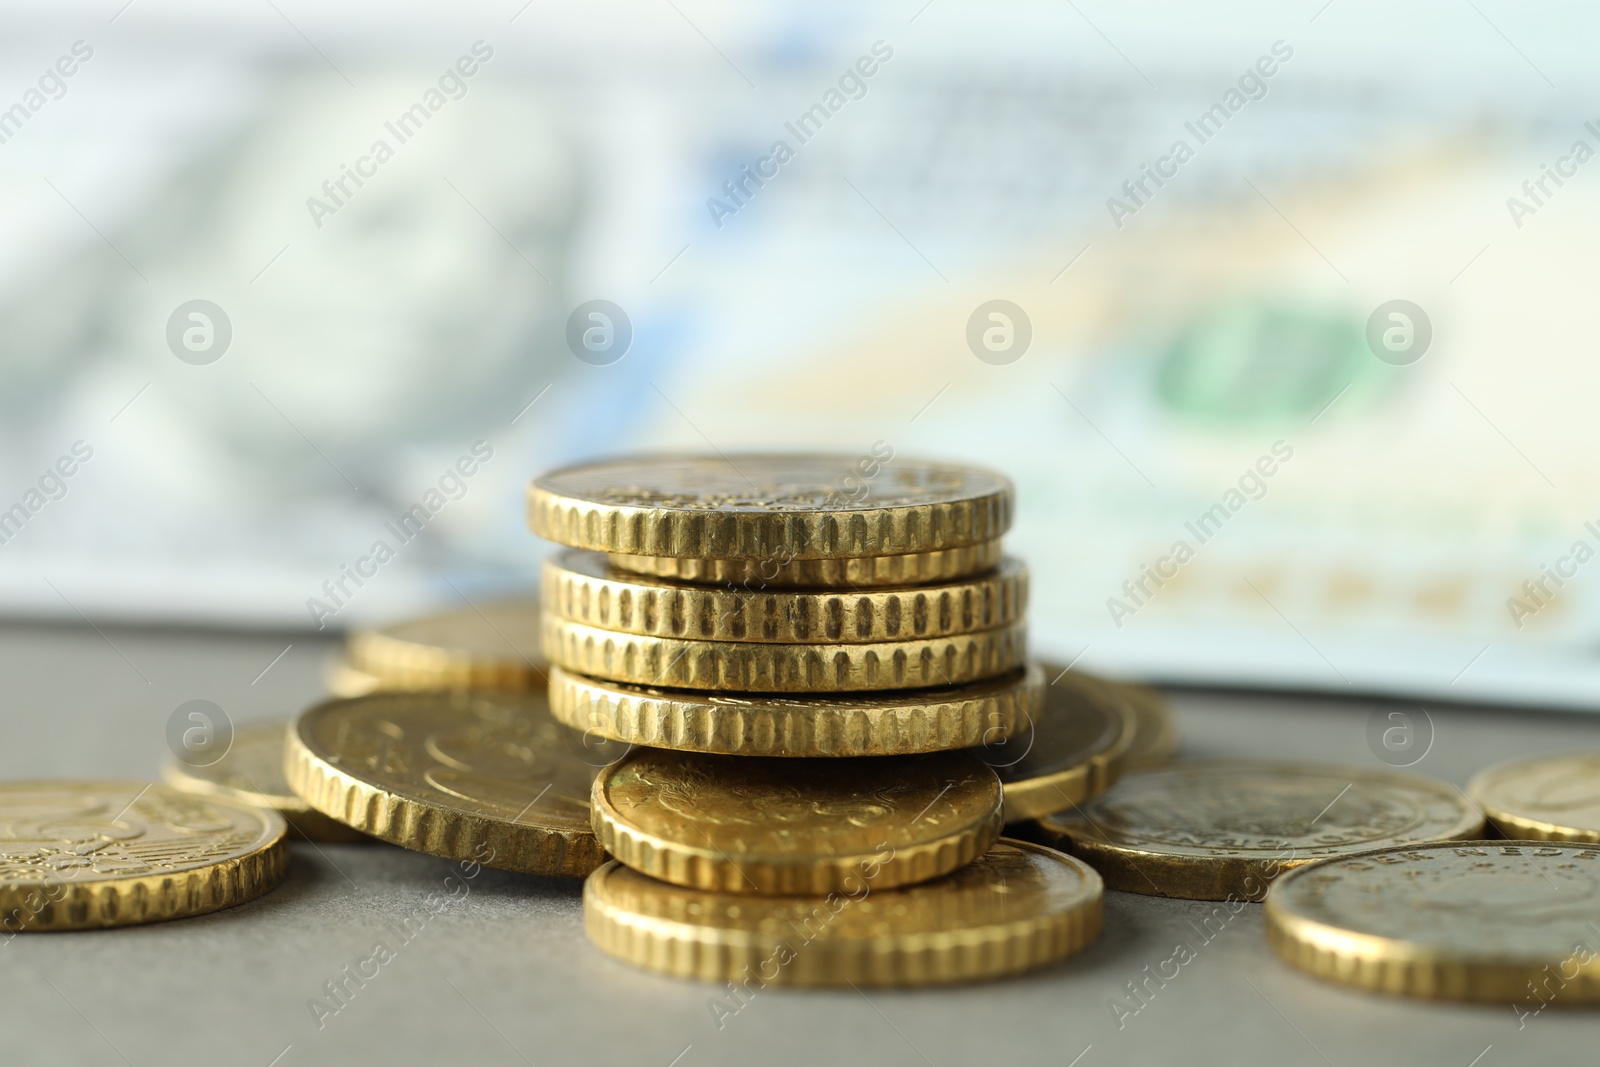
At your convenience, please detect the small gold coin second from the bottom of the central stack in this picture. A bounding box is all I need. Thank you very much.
[590,749,1000,893]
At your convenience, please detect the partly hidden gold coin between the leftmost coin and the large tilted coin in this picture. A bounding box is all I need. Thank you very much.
[162,721,371,843]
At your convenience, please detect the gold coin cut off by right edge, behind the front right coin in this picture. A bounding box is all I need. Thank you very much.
[1467,752,1600,841]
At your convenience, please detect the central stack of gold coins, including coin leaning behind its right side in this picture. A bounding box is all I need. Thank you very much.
[530,454,1131,985]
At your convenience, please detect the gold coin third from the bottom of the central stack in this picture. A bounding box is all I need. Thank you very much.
[550,667,1045,757]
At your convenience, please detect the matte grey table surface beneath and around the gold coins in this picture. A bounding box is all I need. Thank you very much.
[0,625,1600,1067]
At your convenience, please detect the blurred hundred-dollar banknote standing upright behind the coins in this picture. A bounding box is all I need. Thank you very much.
[0,0,1600,710]
